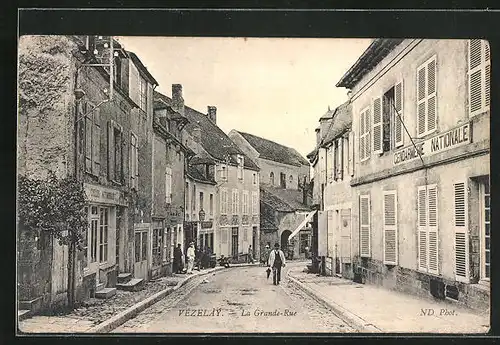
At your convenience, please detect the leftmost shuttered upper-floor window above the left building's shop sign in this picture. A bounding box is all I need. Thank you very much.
[78,101,101,176]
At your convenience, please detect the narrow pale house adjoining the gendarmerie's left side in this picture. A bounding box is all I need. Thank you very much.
[308,101,354,278]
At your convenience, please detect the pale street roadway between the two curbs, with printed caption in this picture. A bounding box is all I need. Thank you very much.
[113,262,353,333]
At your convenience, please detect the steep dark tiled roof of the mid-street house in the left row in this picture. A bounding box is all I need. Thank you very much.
[154,91,260,171]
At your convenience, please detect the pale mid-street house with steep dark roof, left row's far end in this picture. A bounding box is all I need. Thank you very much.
[155,87,260,261]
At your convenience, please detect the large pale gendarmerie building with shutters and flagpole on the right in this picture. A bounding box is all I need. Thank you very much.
[337,39,490,309]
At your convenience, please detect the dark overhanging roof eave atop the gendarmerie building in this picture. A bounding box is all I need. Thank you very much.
[335,38,403,89]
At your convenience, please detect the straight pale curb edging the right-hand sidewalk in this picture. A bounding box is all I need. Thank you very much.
[287,271,383,333]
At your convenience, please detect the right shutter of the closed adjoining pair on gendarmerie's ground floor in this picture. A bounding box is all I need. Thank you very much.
[427,185,439,274]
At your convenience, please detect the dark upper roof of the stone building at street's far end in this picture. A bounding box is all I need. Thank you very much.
[236,131,309,166]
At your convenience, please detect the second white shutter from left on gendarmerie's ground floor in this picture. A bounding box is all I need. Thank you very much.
[383,191,398,265]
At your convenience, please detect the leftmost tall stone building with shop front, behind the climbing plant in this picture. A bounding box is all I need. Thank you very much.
[18,36,157,309]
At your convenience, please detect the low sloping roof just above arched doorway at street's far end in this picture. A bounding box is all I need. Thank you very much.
[260,185,311,212]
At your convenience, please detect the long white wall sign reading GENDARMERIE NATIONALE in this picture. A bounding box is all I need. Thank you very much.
[394,123,471,165]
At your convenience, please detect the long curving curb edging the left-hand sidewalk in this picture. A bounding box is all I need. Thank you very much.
[85,263,258,333]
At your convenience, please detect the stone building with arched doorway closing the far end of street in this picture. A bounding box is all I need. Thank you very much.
[228,129,314,257]
